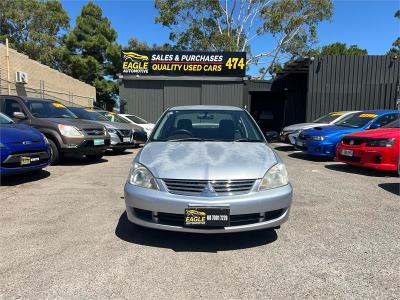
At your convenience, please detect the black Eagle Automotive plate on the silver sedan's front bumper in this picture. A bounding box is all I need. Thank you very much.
[184,207,230,227]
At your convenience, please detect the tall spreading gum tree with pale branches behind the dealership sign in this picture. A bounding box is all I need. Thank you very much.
[155,0,333,78]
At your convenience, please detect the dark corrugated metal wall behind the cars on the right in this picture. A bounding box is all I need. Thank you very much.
[306,55,400,121]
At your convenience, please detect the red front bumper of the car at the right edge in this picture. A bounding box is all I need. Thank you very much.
[335,145,399,171]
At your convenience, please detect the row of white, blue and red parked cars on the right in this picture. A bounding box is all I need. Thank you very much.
[281,110,400,171]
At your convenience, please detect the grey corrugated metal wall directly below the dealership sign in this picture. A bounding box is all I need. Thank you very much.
[119,80,244,122]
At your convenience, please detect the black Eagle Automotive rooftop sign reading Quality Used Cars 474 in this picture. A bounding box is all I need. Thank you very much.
[121,50,246,77]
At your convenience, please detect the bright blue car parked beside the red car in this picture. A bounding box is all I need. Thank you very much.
[296,110,400,158]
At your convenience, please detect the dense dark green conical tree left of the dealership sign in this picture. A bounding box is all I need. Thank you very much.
[64,2,121,109]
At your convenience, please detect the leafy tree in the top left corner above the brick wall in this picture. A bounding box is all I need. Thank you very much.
[0,0,69,69]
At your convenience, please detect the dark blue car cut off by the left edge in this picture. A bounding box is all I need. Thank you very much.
[0,113,51,175]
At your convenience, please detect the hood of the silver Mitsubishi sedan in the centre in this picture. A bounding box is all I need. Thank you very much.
[136,142,278,180]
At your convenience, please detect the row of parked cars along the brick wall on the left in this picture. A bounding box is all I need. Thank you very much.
[0,96,151,175]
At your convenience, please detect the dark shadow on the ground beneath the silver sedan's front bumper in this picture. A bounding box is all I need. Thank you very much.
[115,212,277,253]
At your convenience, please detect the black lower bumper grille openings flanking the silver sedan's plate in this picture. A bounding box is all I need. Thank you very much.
[132,208,286,229]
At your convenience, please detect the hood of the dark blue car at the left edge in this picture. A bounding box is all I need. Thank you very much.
[0,124,44,144]
